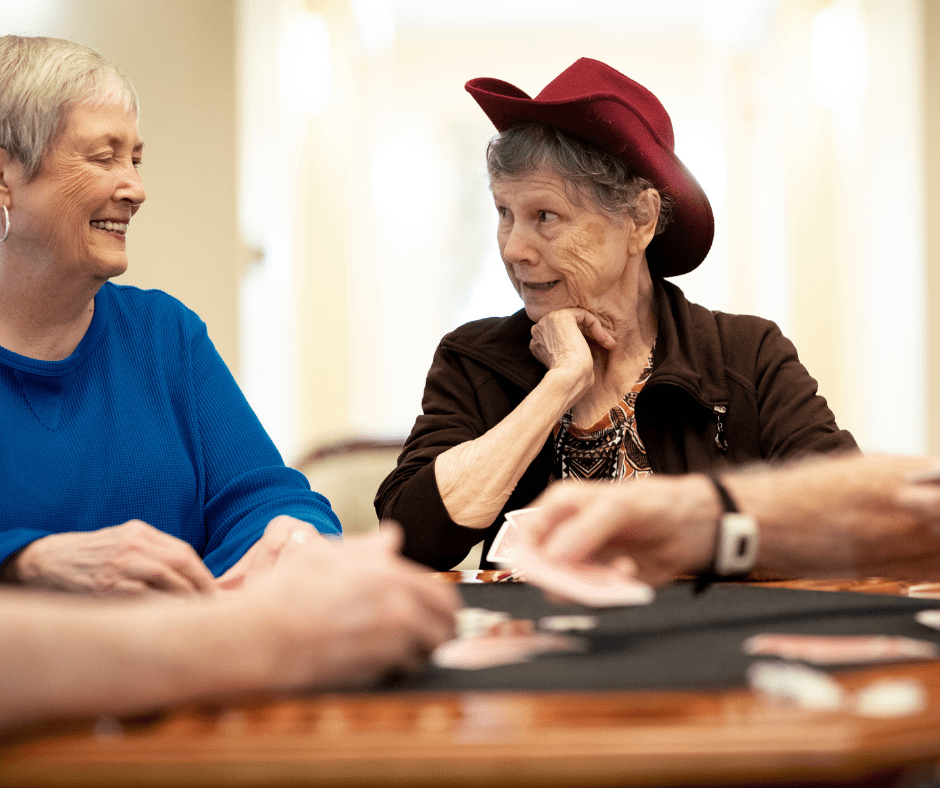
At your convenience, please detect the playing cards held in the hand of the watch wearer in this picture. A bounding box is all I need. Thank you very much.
[486,509,654,607]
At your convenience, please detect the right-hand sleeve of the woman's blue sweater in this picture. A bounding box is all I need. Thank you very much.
[192,321,341,576]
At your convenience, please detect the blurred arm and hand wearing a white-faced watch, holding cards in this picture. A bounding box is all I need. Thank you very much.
[527,455,940,584]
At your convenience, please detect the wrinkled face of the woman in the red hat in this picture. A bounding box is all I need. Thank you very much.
[492,169,633,322]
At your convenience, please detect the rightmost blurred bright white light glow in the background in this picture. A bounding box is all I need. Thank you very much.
[810,0,868,110]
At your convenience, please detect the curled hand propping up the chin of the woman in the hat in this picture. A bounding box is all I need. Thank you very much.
[529,308,617,388]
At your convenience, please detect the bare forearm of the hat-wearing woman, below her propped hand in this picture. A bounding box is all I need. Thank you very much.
[435,370,577,528]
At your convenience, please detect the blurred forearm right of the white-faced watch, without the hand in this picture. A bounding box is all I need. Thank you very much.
[722,456,940,579]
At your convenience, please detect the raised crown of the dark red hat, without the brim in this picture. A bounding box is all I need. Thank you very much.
[535,57,676,151]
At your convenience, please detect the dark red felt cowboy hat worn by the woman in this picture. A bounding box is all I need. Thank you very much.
[466,57,715,276]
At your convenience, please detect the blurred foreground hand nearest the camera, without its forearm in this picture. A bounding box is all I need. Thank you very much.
[244,524,460,689]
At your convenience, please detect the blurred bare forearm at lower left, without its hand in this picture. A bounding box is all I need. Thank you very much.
[0,593,266,727]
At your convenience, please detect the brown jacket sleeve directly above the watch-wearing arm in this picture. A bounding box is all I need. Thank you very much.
[756,323,858,461]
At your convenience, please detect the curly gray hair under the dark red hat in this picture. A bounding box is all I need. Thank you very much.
[486,123,672,235]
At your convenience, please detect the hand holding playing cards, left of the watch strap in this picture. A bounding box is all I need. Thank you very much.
[520,475,721,585]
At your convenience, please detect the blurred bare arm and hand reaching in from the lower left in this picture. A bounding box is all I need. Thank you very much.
[0,530,458,728]
